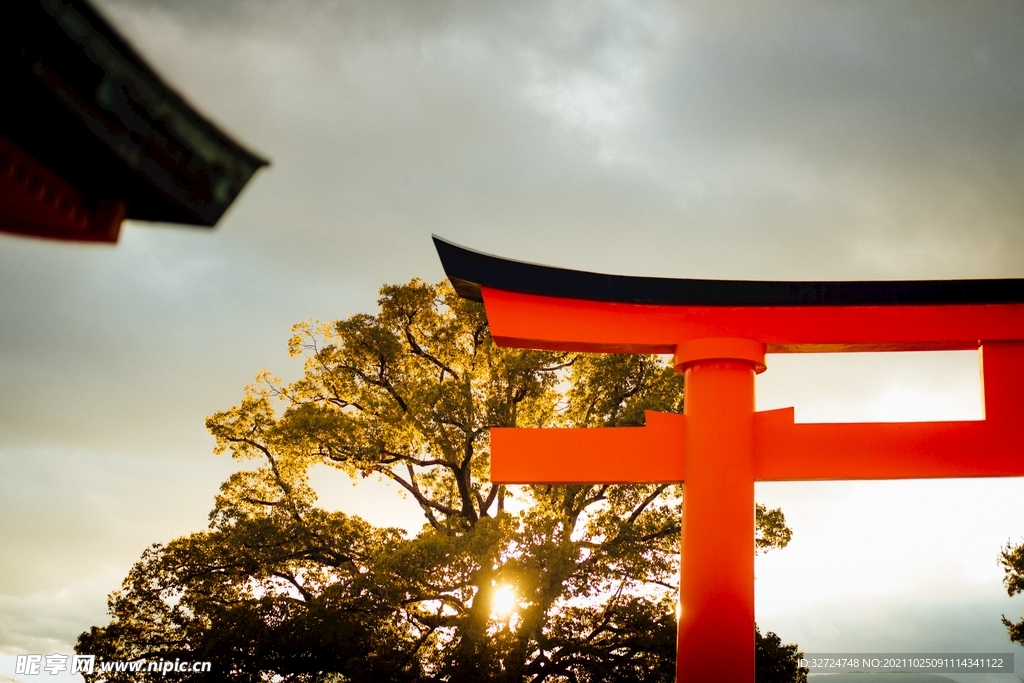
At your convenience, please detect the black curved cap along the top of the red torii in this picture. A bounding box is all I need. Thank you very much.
[433,234,1024,306]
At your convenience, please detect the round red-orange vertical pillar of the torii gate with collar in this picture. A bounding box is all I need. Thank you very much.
[675,339,765,681]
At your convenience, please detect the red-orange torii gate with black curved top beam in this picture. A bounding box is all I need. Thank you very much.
[434,237,1024,683]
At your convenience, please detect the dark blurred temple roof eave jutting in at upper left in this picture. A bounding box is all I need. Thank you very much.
[0,0,268,236]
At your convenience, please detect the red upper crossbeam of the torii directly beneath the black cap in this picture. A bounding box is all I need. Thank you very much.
[482,287,1024,353]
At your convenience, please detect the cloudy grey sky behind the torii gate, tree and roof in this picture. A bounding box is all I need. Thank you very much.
[0,0,1024,682]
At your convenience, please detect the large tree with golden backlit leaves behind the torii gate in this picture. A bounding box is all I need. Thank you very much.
[77,281,806,683]
